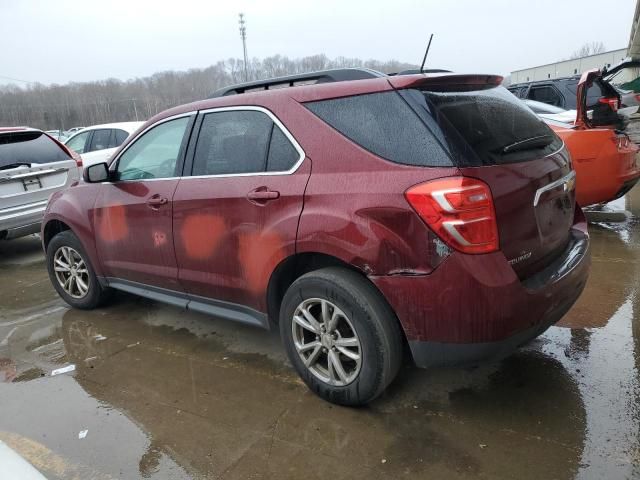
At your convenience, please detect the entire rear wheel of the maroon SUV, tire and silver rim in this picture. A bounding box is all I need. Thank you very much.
[280,267,402,406]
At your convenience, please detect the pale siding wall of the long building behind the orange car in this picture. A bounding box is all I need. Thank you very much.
[511,48,638,83]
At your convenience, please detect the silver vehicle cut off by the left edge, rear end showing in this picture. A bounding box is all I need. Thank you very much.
[0,127,80,240]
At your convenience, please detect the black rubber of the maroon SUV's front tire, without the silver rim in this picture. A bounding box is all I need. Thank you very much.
[47,230,111,310]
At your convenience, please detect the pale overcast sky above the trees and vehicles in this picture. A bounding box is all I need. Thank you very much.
[0,0,636,85]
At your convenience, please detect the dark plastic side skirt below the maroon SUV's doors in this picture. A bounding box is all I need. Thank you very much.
[98,277,269,330]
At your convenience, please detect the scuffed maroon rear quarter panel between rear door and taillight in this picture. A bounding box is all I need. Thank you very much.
[286,104,458,275]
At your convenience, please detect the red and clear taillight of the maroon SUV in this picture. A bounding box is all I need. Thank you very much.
[405,177,499,253]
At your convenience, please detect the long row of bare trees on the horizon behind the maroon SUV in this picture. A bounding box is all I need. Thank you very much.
[0,54,417,130]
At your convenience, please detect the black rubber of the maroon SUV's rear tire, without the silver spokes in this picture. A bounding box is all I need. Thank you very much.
[279,267,402,406]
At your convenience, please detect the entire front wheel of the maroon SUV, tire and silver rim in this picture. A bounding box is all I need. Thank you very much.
[47,230,111,310]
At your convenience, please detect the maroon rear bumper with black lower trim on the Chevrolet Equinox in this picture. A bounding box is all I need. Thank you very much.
[371,222,590,367]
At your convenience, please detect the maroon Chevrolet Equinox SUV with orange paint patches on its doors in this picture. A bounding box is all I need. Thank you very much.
[42,70,589,405]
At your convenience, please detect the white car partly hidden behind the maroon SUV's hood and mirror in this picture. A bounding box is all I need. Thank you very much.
[64,122,144,167]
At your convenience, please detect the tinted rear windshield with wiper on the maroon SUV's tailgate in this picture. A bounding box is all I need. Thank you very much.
[402,87,562,166]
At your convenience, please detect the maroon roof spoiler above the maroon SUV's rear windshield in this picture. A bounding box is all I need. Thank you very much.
[388,74,503,91]
